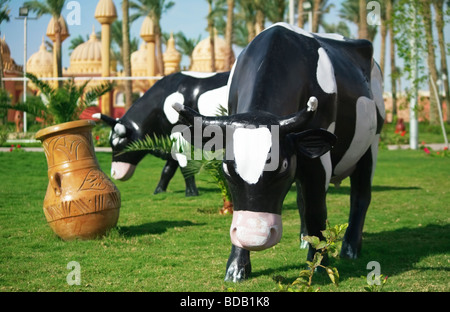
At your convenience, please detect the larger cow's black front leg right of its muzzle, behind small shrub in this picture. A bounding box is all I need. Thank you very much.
[297,156,328,261]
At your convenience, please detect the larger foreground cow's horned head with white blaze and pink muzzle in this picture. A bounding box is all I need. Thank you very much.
[173,97,336,250]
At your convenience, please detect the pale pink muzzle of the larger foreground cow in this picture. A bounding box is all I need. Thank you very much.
[230,210,283,251]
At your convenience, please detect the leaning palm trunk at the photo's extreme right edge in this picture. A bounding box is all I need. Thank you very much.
[433,1,450,124]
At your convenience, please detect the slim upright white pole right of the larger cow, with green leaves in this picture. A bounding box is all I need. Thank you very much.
[409,5,419,150]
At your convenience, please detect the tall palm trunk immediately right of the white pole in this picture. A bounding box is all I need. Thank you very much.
[421,1,438,124]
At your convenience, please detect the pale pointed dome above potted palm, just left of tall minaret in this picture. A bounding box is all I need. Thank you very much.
[67,29,102,73]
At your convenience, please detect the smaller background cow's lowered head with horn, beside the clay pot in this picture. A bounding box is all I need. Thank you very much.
[92,113,146,181]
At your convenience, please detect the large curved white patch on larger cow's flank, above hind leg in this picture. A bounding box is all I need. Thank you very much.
[334,96,377,176]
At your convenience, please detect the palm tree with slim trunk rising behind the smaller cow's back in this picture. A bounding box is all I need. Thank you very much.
[129,0,175,73]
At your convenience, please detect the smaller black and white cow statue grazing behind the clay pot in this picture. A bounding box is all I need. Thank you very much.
[93,72,230,196]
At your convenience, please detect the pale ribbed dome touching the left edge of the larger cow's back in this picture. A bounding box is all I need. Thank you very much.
[190,35,234,72]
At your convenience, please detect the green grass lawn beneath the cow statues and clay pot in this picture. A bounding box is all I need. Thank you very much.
[0,150,450,292]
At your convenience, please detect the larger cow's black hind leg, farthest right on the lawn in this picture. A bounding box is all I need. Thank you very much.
[341,144,377,259]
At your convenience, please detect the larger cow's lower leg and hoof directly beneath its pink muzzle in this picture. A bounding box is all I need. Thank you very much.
[225,245,252,283]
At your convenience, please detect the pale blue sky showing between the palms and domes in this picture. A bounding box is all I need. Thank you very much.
[0,0,450,89]
